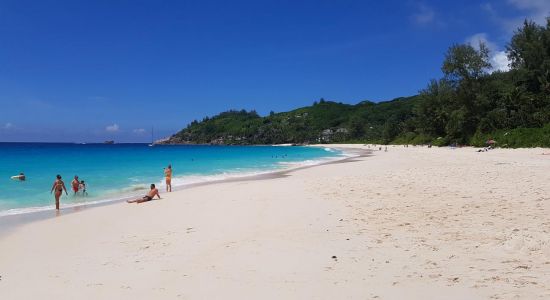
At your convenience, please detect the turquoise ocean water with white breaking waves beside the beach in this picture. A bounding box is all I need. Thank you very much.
[0,143,343,217]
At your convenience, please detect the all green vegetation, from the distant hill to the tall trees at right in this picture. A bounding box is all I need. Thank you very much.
[168,18,550,147]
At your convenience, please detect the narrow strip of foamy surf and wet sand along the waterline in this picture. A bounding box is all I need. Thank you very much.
[0,144,372,238]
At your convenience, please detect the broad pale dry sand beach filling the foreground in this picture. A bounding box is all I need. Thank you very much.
[0,146,550,299]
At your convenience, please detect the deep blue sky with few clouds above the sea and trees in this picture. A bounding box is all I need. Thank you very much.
[0,0,550,142]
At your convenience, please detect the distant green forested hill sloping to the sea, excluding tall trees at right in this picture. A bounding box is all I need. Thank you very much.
[169,97,418,144]
